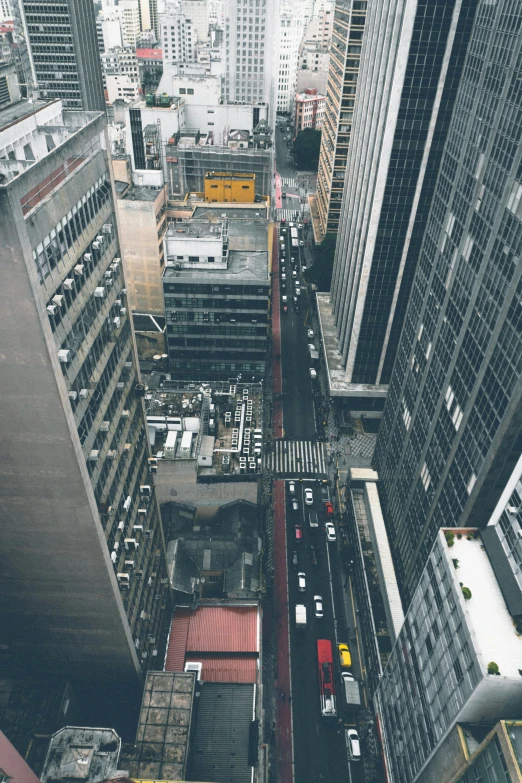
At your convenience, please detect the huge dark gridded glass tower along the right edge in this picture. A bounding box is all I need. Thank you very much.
[375,0,522,597]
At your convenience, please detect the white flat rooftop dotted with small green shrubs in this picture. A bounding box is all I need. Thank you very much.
[439,529,522,681]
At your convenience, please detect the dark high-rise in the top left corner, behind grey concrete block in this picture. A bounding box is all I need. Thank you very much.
[13,0,105,111]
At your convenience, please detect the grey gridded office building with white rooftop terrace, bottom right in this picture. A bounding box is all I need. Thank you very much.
[374,528,522,783]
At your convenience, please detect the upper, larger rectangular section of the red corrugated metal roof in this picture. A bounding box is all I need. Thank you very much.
[186,606,259,653]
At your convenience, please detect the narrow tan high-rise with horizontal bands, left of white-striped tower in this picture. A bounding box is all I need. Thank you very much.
[307,0,367,240]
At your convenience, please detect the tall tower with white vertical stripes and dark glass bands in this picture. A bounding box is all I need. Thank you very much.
[314,0,476,402]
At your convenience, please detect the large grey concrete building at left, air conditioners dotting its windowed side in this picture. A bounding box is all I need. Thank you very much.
[0,100,170,698]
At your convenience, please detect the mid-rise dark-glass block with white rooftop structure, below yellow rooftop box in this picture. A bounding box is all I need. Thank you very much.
[163,213,270,381]
